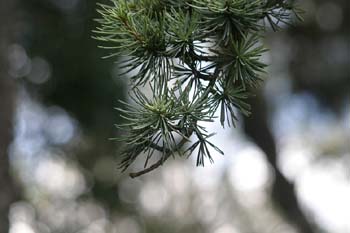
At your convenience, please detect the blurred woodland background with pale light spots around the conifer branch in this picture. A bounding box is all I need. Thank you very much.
[0,0,350,233]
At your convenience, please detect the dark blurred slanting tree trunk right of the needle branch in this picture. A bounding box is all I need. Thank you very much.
[245,93,318,233]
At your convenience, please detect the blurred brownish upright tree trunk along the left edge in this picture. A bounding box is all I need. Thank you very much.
[0,0,16,233]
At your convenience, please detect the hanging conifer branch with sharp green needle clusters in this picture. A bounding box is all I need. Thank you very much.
[94,0,299,177]
